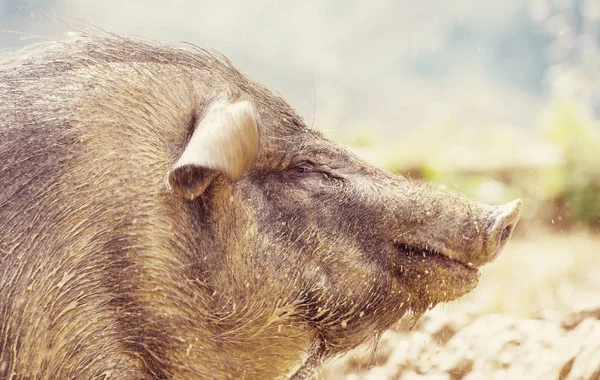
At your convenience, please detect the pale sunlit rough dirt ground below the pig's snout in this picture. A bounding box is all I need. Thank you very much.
[318,229,600,380]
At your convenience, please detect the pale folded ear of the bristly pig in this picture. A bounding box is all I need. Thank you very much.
[168,100,259,200]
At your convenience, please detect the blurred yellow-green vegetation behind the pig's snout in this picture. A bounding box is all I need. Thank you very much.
[346,100,600,232]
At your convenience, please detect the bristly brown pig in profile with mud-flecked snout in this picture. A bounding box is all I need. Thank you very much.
[0,33,522,379]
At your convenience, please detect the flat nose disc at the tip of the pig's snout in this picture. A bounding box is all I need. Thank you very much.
[478,199,523,265]
